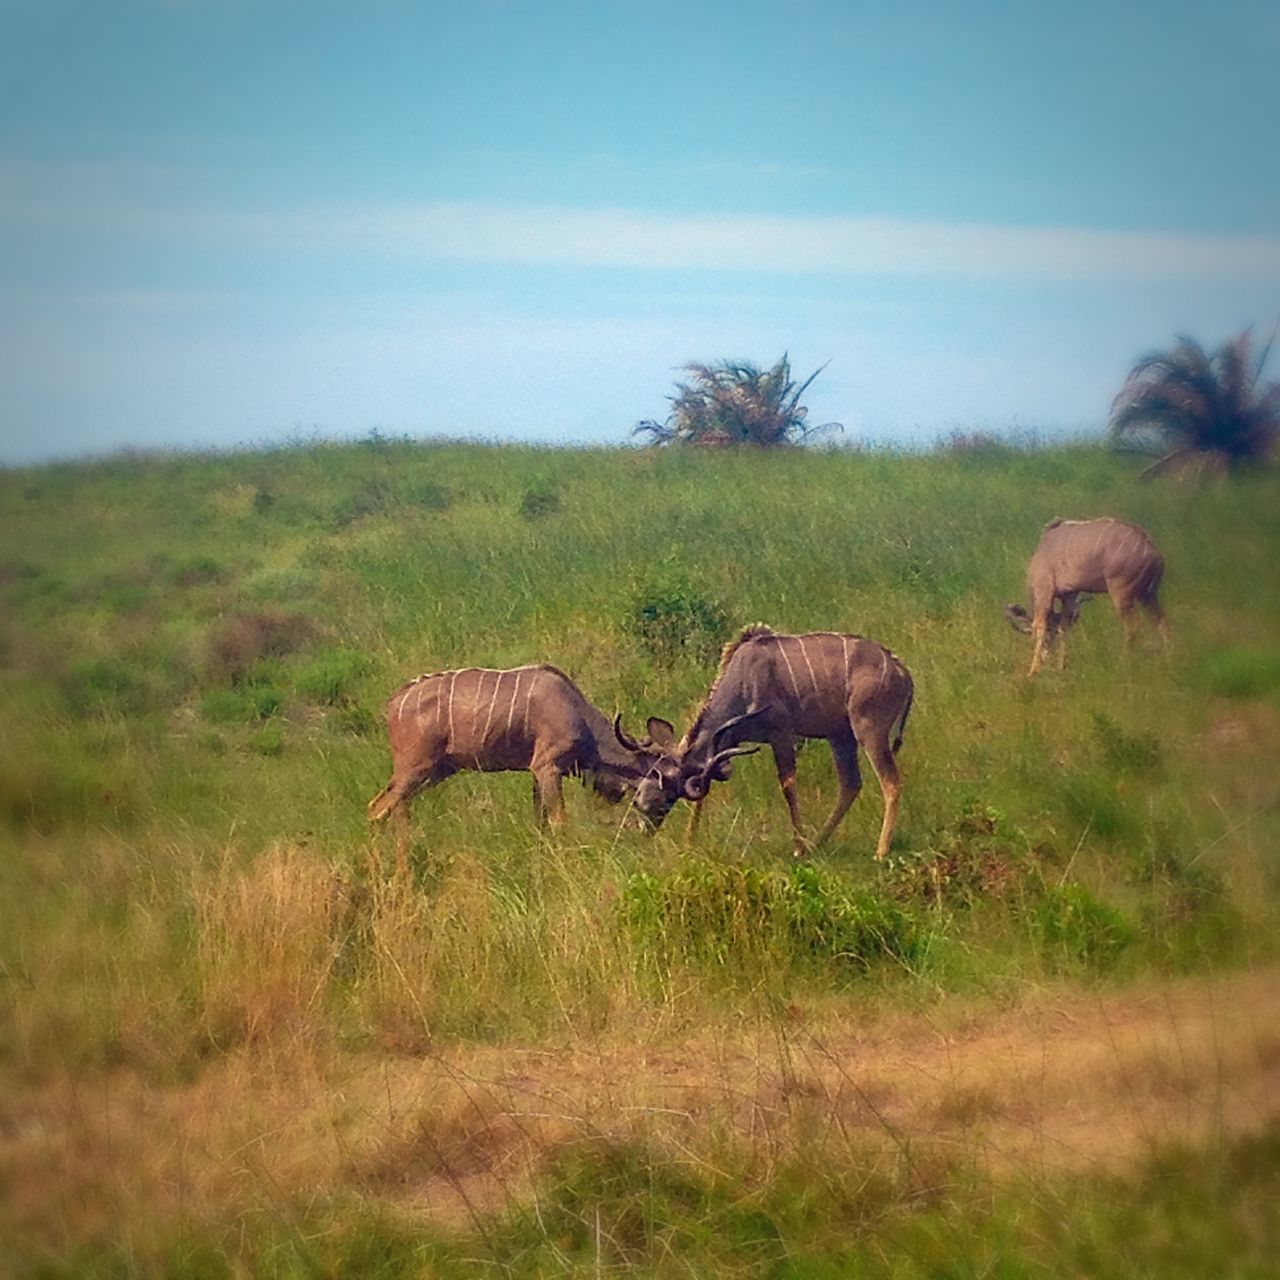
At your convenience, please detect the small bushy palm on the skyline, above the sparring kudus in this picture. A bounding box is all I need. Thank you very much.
[634,355,844,448]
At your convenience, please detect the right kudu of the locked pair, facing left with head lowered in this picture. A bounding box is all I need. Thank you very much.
[678,623,914,858]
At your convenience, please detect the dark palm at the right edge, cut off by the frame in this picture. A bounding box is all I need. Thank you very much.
[1110,325,1280,479]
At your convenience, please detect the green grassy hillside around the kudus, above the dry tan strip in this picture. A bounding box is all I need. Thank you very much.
[0,438,1280,1274]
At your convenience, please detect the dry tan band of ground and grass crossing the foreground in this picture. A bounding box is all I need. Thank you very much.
[0,970,1280,1249]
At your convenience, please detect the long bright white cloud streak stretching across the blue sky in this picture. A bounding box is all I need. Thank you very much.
[282,202,1280,283]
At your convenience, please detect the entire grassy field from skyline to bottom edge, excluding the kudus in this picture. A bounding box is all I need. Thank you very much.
[0,436,1280,1276]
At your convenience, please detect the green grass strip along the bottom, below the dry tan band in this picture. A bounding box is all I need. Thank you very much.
[23,1128,1280,1280]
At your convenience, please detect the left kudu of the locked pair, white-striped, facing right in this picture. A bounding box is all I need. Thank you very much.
[369,664,680,859]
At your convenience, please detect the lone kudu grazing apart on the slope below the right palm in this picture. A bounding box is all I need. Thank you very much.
[1005,517,1169,676]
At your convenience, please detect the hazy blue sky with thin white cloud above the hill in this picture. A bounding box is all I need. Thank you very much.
[0,0,1280,466]
